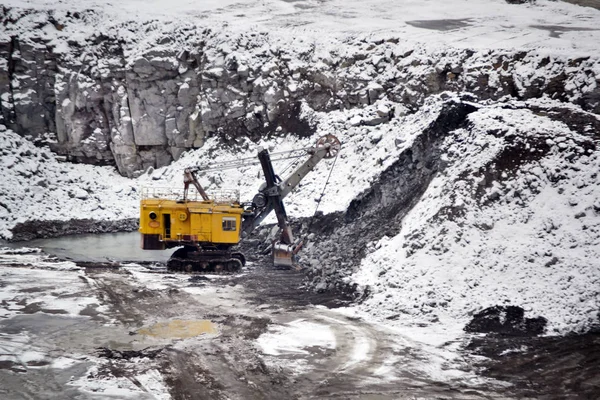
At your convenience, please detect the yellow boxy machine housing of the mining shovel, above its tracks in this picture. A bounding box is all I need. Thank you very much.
[139,199,244,249]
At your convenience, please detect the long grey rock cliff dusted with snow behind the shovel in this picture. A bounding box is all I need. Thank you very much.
[0,8,600,177]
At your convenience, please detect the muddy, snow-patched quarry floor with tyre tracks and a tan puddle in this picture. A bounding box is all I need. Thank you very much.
[0,236,600,399]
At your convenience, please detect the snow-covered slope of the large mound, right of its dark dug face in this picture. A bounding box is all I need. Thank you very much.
[348,102,600,337]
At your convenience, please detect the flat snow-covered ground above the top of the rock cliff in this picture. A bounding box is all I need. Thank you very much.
[4,0,600,53]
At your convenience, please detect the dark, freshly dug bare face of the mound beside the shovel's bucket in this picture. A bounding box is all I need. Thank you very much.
[304,100,477,290]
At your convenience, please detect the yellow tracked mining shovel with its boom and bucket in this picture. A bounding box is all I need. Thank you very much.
[139,135,341,272]
